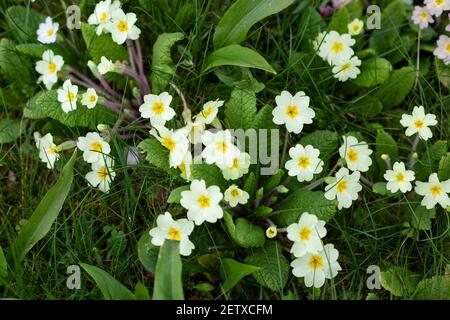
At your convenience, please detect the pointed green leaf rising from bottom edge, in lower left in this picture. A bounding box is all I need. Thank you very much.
[80,263,135,300]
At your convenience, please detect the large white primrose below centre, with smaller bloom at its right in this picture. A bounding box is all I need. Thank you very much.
[180,180,223,225]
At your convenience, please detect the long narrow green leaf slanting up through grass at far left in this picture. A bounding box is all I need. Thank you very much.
[10,151,77,264]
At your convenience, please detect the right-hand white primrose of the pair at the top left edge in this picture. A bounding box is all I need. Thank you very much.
[106,9,141,44]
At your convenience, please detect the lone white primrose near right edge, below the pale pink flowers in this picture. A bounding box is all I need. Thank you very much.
[400,106,437,141]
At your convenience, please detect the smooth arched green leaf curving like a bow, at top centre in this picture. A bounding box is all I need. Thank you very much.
[202,44,276,74]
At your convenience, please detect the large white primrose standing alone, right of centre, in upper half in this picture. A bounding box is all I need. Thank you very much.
[272,91,316,134]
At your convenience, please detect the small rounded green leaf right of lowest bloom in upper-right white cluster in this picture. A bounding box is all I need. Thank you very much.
[352,58,392,88]
